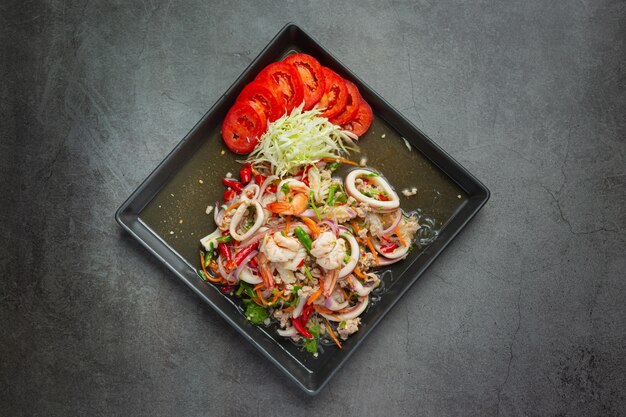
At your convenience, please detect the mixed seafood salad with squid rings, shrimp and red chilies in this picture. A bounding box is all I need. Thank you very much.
[199,157,420,356]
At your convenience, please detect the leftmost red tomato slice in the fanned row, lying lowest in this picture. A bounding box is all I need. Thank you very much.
[222,101,267,154]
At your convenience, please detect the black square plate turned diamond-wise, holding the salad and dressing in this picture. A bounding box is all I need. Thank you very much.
[115,24,489,394]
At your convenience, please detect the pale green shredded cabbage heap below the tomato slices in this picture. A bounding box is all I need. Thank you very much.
[248,103,359,178]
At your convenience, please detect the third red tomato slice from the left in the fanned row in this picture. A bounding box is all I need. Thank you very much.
[255,62,304,112]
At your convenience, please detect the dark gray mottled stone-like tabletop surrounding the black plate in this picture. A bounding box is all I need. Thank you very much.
[0,0,626,416]
